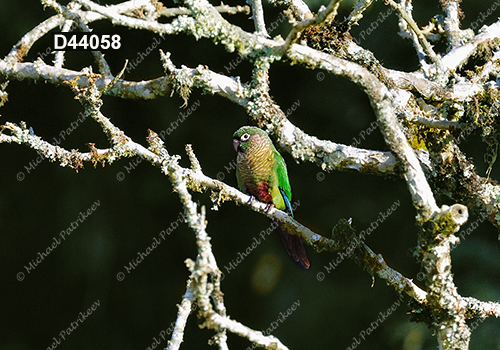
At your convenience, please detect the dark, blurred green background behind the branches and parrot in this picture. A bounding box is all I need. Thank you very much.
[0,0,500,350]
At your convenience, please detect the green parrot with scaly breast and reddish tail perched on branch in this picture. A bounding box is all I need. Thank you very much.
[233,126,310,270]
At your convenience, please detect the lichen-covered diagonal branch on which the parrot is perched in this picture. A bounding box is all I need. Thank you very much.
[0,106,423,302]
